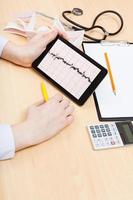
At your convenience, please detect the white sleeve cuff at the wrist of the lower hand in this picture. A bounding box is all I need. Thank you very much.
[0,124,15,160]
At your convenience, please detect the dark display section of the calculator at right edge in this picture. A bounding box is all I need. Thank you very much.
[116,122,133,144]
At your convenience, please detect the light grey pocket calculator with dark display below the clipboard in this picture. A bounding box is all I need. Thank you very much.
[87,121,133,150]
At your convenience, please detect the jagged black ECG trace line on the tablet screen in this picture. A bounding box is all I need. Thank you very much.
[49,52,91,83]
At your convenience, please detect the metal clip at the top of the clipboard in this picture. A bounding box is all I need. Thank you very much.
[100,40,131,47]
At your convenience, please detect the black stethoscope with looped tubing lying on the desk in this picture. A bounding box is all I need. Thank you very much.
[62,8,123,42]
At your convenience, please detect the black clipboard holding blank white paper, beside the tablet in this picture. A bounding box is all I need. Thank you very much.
[82,41,133,121]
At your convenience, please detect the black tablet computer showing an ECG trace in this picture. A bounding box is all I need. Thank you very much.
[32,36,107,105]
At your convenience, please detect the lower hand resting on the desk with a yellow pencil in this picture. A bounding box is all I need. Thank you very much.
[12,94,74,151]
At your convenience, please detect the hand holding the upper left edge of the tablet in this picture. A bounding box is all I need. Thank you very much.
[1,29,66,67]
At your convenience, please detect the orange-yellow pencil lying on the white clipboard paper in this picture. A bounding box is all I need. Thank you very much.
[104,53,116,95]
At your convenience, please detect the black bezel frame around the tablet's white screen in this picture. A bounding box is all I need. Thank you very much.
[32,35,107,105]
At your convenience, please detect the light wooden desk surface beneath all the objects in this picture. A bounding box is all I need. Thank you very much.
[0,0,133,200]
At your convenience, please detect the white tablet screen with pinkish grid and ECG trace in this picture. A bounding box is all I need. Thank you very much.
[38,40,100,99]
